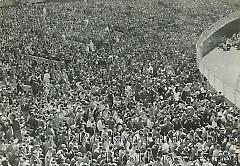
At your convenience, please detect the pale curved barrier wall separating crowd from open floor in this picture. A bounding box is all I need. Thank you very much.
[196,11,240,107]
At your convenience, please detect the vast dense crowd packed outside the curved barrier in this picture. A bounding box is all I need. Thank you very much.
[0,0,240,166]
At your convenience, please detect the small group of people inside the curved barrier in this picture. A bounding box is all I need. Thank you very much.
[219,32,240,51]
